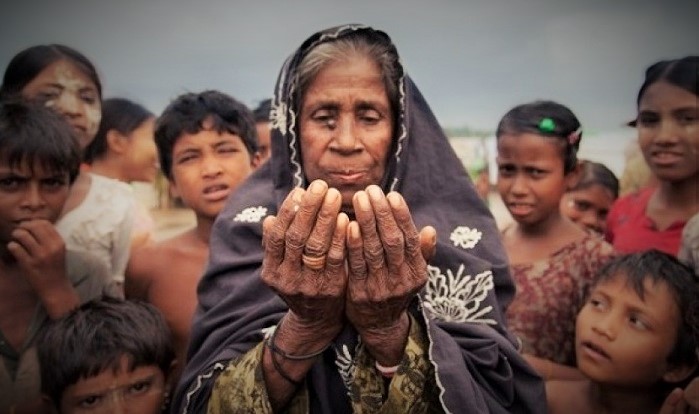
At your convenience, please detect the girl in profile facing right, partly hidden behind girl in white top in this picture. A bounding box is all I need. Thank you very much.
[84,98,158,249]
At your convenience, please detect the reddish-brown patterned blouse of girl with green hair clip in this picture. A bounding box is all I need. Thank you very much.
[506,235,614,366]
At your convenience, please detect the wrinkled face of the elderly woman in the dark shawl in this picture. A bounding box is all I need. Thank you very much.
[299,56,393,212]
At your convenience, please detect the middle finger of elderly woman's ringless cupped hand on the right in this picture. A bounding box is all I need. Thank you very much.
[367,185,405,273]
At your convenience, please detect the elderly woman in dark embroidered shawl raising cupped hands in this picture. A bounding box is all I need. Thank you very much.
[174,25,546,413]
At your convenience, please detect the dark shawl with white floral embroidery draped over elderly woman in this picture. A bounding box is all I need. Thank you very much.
[174,25,546,413]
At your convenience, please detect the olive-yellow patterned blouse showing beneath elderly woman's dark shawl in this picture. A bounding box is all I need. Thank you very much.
[208,315,440,414]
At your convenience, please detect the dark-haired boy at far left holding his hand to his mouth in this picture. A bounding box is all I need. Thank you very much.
[0,98,116,414]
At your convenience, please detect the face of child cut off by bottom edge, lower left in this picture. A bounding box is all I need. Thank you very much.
[60,357,166,414]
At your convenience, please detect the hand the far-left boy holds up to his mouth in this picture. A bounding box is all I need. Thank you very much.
[7,220,66,296]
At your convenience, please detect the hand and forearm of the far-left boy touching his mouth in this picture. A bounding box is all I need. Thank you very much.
[7,220,80,319]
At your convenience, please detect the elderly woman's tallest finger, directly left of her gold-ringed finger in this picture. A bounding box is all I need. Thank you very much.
[284,180,328,261]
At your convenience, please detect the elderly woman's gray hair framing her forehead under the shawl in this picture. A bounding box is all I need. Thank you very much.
[295,30,401,119]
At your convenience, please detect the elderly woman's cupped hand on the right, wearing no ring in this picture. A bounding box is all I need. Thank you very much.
[345,185,436,341]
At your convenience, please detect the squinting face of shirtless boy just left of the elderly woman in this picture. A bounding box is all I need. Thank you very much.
[171,129,257,218]
